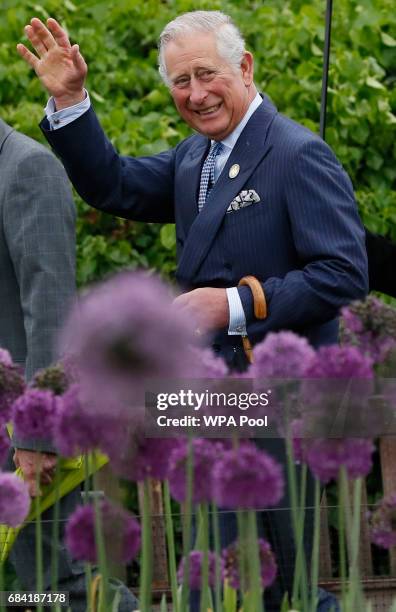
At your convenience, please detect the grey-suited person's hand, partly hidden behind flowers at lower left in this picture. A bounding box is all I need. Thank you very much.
[14,448,57,497]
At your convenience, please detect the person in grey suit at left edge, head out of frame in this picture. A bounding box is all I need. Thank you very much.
[0,119,89,610]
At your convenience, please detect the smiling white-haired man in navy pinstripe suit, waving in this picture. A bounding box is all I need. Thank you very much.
[18,11,367,611]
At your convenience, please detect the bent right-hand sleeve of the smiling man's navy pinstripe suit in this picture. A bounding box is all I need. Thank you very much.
[239,139,368,341]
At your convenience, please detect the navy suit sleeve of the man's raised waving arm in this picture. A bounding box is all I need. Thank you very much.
[40,107,175,223]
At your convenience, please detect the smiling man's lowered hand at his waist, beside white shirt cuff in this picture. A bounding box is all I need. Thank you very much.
[174,287,230,334]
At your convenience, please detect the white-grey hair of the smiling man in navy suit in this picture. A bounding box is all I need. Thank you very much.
[158,11,245,87]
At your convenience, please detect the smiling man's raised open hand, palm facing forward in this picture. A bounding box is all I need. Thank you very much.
[17,17,88,110]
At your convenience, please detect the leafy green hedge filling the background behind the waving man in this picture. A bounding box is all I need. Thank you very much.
[0,0,396,284]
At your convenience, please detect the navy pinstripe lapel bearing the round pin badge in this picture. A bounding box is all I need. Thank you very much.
[176,98,277,286]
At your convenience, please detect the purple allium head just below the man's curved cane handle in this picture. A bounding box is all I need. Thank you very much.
[249,331,315,378]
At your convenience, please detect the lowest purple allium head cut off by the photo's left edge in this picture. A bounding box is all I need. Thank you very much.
[0,472,30,527]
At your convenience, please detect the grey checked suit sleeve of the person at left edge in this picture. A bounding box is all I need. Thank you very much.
[4,149,76,452]
